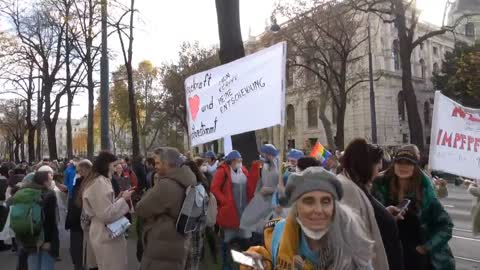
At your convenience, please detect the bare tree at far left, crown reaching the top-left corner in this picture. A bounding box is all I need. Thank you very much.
[2,1,66,159]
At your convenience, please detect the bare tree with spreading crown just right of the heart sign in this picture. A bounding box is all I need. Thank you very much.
[275,0,368,149]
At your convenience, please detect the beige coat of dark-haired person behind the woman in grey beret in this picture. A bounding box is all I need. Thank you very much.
[337,174,389,270]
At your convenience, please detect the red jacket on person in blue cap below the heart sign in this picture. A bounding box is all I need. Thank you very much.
[210,163,250,229]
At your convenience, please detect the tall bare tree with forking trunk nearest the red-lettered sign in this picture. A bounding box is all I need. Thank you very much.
[348,0,470,150]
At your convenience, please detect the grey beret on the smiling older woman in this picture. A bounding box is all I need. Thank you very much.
[281,167,343,207]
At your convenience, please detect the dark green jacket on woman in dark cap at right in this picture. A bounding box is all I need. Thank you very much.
[372,176,455,270]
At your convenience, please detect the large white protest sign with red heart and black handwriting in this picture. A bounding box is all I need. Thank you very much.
[185,42,287,146]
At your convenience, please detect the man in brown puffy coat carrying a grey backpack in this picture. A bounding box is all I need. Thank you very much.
[135,147,197,270]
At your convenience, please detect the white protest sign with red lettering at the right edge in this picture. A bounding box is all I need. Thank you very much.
[429,91,480,179]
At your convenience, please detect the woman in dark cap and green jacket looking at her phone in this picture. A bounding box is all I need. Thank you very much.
[372,146,455,270]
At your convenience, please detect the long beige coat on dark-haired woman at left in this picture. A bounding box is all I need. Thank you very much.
[83,176,129,270]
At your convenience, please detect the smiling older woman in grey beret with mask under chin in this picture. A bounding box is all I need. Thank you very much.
[240,167,374,270]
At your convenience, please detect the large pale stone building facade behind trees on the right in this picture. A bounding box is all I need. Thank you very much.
[246,0,480,152]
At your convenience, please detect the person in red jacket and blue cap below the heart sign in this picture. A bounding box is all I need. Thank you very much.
[210,150,253,270]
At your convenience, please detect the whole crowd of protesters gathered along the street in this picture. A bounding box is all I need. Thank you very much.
[0,139,462,270]
